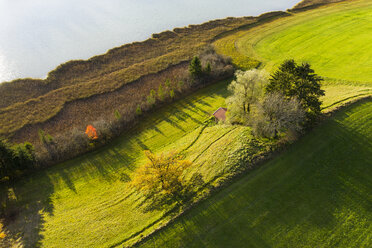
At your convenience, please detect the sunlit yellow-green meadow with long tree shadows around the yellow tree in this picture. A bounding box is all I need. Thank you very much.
[1,81,265,247]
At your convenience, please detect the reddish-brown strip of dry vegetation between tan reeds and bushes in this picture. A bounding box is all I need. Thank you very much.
[13,63,188,142]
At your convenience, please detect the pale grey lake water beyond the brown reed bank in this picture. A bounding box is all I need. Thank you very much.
[0,0,300,82]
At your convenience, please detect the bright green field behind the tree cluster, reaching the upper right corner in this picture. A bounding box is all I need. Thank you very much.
[215,0,372,109]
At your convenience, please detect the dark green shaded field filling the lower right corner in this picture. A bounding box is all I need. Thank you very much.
[139,100,372,248]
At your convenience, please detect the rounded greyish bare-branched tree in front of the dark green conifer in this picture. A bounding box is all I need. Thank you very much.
[253,92,305,138]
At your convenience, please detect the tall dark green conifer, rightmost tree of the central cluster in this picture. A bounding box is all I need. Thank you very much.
[266,60,324,121]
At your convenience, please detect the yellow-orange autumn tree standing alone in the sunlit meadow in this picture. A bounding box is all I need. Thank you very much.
[131,151,192,198]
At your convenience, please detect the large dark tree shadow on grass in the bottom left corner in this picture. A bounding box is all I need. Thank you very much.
[0,172,54,247]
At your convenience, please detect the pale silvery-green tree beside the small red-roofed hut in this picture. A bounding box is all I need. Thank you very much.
[227,69,267,122]
